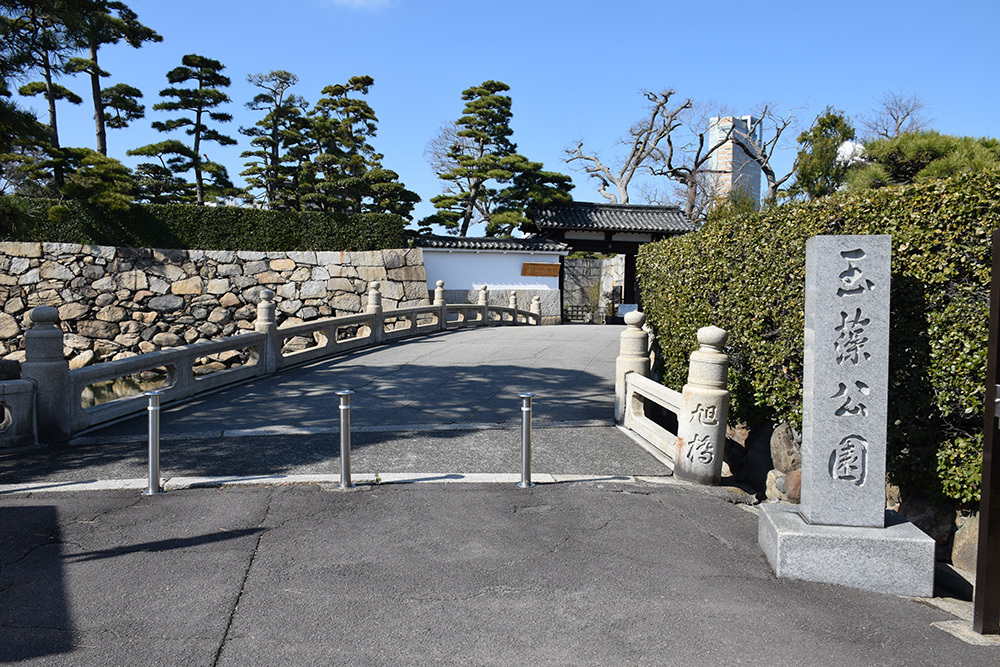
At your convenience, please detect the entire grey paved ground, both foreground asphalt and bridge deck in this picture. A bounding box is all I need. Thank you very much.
[0,326,1000,666]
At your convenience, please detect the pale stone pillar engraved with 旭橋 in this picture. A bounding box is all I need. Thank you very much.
[674,327,729,484]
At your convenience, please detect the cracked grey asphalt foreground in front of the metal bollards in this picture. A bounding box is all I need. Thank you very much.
[0,481,997,665]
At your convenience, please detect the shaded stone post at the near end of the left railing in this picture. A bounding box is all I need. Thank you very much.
[21,306,71,442]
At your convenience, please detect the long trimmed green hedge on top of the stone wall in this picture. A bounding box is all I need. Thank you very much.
[0,197,407,251]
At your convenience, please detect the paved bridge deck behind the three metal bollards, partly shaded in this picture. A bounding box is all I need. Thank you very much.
[0,326,669,490]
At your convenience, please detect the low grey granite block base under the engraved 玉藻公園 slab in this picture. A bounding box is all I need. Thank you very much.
[757,505,934,597]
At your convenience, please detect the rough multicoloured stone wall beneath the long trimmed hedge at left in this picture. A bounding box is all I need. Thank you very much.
[0,242,429,368]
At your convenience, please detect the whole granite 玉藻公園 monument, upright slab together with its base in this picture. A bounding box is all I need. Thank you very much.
[758,236,934,597]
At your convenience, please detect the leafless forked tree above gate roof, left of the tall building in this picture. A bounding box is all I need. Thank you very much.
[566,90,691,204]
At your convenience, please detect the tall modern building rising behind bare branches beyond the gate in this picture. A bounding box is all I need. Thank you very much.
[708,116,763,201]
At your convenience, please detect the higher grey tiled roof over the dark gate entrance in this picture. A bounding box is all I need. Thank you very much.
[535,202,697,234]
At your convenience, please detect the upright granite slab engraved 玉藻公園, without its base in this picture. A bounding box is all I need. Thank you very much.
[800,236,892,528]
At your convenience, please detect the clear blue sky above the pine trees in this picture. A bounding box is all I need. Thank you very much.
[11,0,1000,234]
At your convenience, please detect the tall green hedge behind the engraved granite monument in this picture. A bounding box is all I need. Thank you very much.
[637,169,1000,502]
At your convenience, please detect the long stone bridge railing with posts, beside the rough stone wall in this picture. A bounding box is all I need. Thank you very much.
[9,281,541,445]
